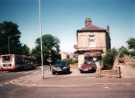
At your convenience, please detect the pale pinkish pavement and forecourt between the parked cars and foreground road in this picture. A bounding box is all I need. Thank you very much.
[0,68,135,87]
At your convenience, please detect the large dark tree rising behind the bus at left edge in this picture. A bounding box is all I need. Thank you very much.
[0,21,21,54]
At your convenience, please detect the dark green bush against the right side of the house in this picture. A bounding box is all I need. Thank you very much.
[102,48,118,69]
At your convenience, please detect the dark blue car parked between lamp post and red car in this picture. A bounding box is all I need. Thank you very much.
[52,60,70,74]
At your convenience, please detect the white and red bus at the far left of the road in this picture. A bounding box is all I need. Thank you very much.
[0,54,35,71]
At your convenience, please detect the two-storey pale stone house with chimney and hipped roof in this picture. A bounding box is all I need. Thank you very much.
[74,18,111,66]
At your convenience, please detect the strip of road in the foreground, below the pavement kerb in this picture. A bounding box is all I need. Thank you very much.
[0,84,135,98]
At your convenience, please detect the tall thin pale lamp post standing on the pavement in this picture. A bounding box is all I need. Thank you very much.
[38,0,44,79]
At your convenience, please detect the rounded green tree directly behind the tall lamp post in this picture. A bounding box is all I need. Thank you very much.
[32,34,60,64]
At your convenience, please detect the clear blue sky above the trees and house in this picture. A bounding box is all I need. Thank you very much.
[0,0,135,52]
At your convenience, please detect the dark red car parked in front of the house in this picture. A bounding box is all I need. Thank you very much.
[79,62,97,73]
